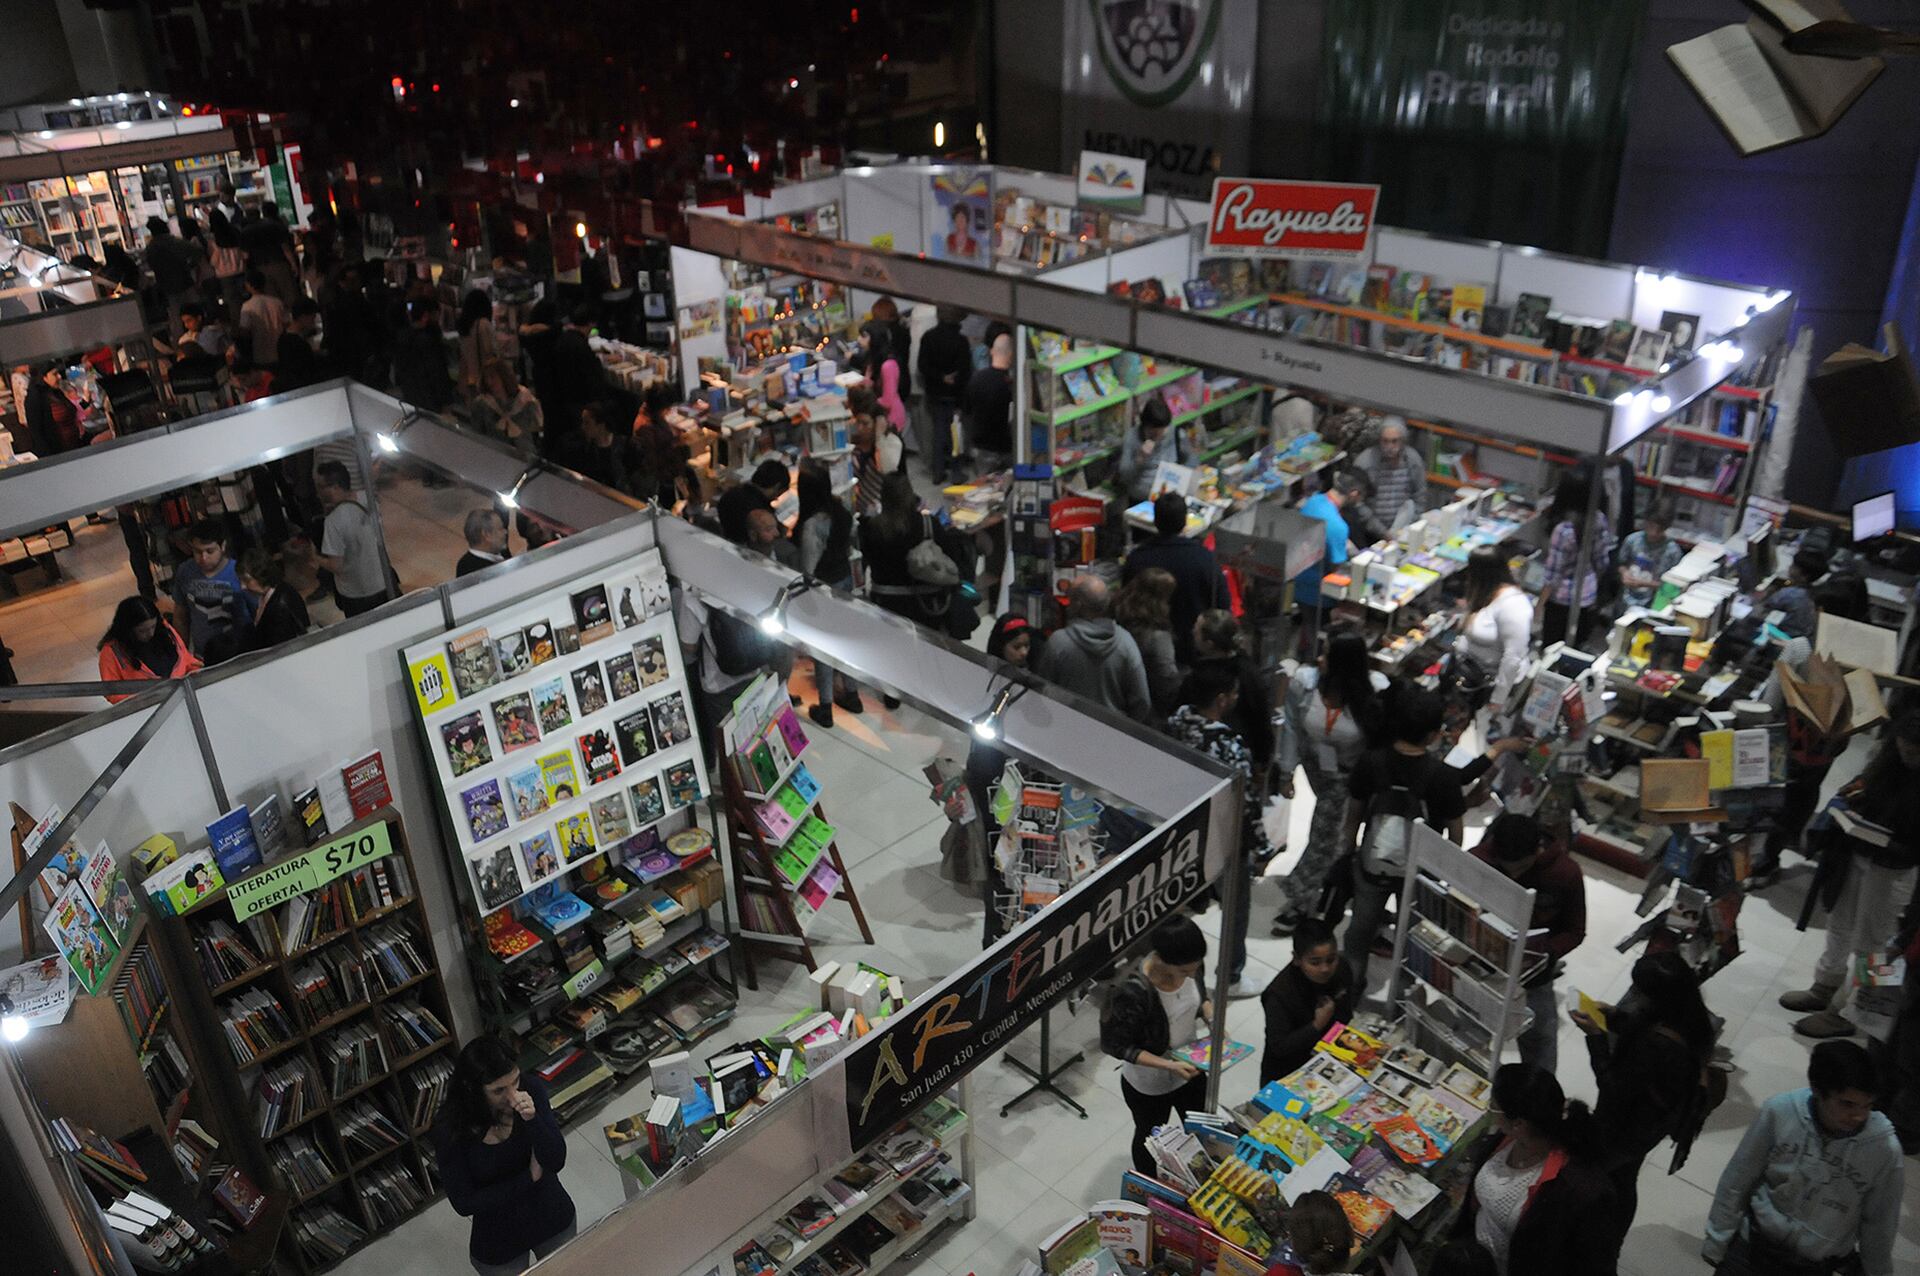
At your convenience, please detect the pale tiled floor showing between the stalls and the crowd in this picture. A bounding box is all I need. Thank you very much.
[0,480,1920,1276]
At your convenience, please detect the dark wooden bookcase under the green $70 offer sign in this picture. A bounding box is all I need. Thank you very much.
[152,806,455,1276]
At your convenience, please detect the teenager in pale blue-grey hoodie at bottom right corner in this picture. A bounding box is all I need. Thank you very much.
[1699,1042,1905,1276]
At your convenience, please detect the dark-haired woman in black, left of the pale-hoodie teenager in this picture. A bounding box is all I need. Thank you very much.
[1572,952,1715,1240]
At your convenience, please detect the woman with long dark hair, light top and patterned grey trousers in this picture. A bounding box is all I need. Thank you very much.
[1273,626,1386,934]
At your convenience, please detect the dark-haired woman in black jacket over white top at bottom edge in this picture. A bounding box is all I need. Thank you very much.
[1461,1063,1620,1276]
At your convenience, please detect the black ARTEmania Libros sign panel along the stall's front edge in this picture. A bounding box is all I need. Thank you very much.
[843,800,1212,1151]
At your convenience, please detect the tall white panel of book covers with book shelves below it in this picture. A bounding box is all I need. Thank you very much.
[401,549,735,1124]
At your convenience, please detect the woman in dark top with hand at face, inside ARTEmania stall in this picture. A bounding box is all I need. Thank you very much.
[434,1036,574,1276]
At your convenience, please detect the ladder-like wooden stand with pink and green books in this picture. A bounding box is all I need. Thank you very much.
[720,675,874,988]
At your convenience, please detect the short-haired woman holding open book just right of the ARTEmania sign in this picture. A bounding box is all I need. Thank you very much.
[1100,917,1213,1174]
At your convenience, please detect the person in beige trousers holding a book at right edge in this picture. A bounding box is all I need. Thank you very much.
[1780,708,1920,1038]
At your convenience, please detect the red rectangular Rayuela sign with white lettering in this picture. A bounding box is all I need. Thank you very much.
[1206,177,1380,257]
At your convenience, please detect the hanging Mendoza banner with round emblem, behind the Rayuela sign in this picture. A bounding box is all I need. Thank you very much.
[1060,0,1260,200]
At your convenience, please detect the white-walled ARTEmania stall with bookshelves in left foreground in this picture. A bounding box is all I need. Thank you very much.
[0,384,1238,1274]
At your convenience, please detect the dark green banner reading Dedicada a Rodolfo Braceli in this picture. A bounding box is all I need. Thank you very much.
[1315,0,1645,265]
